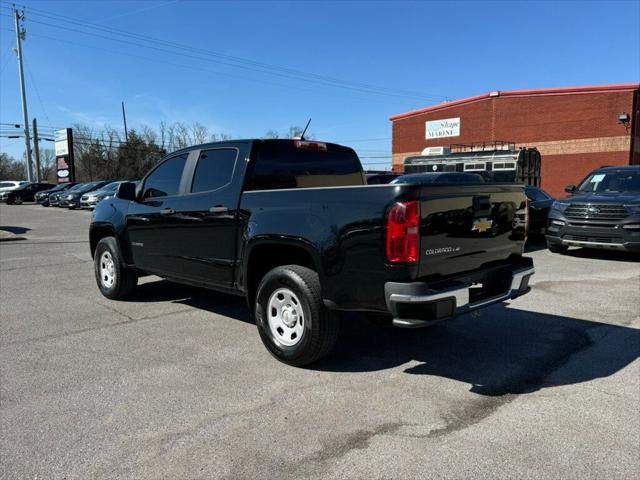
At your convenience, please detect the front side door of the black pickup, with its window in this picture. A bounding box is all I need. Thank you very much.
[126,153,188,276]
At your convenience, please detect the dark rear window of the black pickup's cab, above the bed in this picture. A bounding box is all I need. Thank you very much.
[245,140,365,190]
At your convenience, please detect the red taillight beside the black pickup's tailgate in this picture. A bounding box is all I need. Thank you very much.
[387,201,420,263]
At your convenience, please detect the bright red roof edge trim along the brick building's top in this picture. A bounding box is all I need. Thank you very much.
[389,83,640,122]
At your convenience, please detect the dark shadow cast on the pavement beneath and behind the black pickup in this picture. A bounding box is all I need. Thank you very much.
[127,280,640,396]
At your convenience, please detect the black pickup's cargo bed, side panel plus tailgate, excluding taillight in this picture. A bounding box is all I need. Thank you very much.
[238,184,526,311]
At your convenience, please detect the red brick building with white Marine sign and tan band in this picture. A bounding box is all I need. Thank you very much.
[390,83,640,196]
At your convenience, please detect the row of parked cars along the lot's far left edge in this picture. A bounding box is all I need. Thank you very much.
[0,180,135,209]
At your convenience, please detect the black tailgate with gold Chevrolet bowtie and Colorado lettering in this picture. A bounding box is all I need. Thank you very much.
[418,184,526,277]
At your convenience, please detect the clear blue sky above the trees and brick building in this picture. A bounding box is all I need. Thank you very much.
[0,0,640,168]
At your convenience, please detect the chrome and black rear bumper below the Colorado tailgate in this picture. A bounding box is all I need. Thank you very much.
[384,259,535,328]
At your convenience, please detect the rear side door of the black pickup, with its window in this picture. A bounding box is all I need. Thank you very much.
[179,143,248,288]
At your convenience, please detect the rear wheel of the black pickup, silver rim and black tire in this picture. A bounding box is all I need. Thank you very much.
[255,265,339,367]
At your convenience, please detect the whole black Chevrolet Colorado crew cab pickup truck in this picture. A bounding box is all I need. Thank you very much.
[90,140,534,366]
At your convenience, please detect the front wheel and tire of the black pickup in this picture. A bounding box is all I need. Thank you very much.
[93,237,138,300]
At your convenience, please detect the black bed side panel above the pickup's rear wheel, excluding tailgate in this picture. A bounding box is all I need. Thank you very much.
[238,185,417,309]
